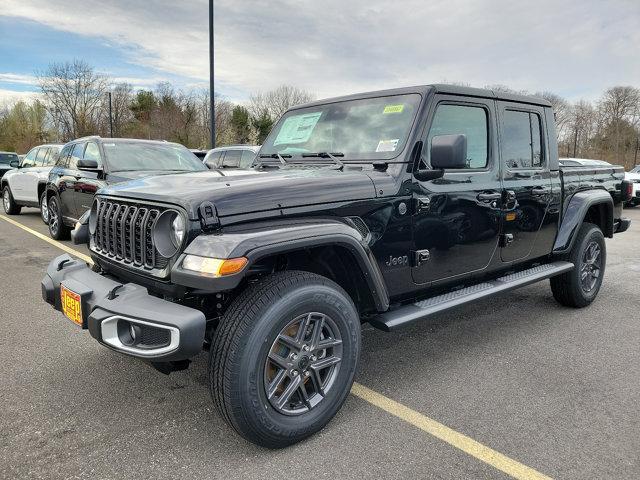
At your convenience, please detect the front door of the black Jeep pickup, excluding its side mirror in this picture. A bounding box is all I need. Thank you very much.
[413,96,502,284]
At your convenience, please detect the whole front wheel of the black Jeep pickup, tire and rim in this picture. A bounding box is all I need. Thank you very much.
[209,271,360,448]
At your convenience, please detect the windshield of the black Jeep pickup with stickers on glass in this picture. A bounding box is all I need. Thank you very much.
[260,94,420,161]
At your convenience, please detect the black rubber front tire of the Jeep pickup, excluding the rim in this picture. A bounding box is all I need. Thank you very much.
[209,271,360,448]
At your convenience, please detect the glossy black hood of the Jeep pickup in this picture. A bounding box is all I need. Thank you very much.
[98,168,376,219]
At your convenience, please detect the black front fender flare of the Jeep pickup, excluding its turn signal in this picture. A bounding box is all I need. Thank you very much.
[171,219,389,312]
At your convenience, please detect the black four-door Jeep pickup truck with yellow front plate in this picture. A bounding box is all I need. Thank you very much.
[42,85,630,448]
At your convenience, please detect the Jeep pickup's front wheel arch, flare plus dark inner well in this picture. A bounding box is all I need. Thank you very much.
[171,220,389,312]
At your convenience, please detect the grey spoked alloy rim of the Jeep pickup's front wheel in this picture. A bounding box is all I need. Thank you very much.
[264,312,342,415]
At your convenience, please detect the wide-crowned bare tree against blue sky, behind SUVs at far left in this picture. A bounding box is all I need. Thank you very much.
[38,60,109,140]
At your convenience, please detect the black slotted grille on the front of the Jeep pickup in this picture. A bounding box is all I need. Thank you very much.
[93,199,169,269]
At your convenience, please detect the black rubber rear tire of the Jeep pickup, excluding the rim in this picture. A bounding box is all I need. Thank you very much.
[551,223,607,308]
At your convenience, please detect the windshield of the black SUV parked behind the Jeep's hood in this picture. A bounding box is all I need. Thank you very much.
[103,142,207,172]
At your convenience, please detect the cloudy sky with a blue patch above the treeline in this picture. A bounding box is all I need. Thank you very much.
[0,0,640,103]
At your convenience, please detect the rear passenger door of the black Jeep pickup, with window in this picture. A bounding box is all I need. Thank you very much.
[497,101,555,262]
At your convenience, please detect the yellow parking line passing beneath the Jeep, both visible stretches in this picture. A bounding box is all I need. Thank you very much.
[0,215,550,480]
